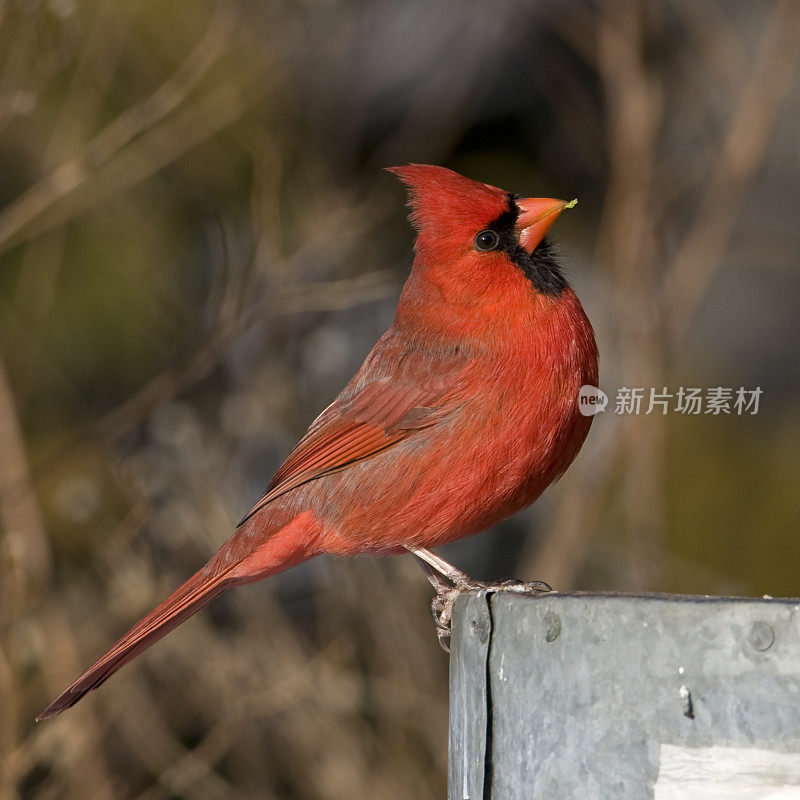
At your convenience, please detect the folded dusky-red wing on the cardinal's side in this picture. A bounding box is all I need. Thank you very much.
[239,339,466,526]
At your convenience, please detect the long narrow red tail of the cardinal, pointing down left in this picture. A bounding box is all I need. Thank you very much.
[36,519,313,722]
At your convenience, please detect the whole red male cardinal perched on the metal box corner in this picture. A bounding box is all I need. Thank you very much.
[37,164,597,720]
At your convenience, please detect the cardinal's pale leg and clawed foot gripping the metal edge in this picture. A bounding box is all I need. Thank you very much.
[407,547,553,653]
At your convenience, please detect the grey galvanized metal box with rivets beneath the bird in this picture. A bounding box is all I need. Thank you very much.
[448,593,800,800]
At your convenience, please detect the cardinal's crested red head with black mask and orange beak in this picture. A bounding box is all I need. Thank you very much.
[389,164,573,334]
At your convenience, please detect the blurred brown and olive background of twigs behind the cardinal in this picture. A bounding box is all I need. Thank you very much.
[0,0,800,800]
